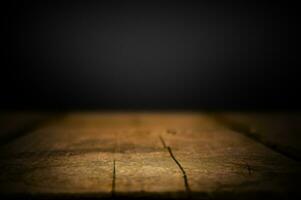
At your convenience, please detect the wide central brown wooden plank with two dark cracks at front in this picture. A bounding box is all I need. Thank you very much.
[0,113,300,199]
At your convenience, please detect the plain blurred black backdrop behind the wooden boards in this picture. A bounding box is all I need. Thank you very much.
[0,1,300,110]
